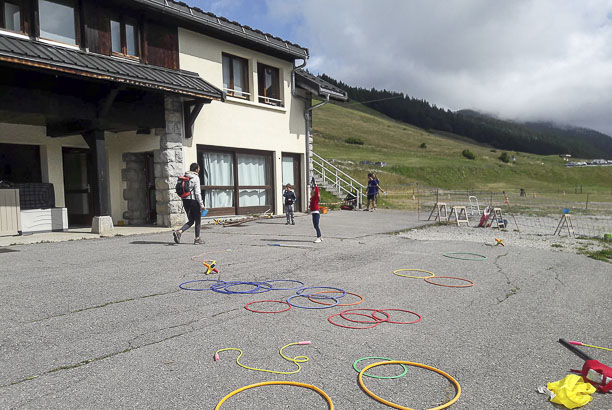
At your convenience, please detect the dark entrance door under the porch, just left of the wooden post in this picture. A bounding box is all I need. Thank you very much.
[62,148,94,225]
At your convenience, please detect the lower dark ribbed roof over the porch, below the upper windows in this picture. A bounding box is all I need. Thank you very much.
[0,35,224,100]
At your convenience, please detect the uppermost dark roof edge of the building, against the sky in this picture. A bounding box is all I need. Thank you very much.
[133,0,308,59]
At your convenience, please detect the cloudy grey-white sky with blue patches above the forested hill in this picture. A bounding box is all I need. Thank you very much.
[192,0,612,135]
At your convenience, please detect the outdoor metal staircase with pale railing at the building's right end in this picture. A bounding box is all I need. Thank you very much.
[312,152,365,209]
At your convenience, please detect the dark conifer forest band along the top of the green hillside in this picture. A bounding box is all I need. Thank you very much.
[321,74,612,159]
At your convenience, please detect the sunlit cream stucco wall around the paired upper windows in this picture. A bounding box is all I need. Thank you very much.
[179,29,306,213]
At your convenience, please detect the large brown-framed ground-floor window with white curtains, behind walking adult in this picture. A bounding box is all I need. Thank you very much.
[198,148,273,215]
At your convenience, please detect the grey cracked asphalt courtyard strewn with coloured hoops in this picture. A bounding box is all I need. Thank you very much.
[0,210,612,409]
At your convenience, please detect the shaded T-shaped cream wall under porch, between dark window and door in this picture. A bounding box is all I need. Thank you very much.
[0,123,89,207]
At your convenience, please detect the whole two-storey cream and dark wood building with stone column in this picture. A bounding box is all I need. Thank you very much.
[0,0,346,231]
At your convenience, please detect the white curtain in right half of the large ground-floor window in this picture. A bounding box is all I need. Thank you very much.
[238,154,270,206]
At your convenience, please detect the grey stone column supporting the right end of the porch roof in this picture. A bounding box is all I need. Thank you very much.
[153,95,185,227]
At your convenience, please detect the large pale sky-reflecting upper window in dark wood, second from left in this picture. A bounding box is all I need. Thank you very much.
[38,0,77,45]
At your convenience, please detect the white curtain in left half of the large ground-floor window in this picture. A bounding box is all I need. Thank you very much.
[202,152,234,208]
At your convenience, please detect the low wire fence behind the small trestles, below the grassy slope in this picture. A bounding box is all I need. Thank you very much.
[381,184,612,238]
